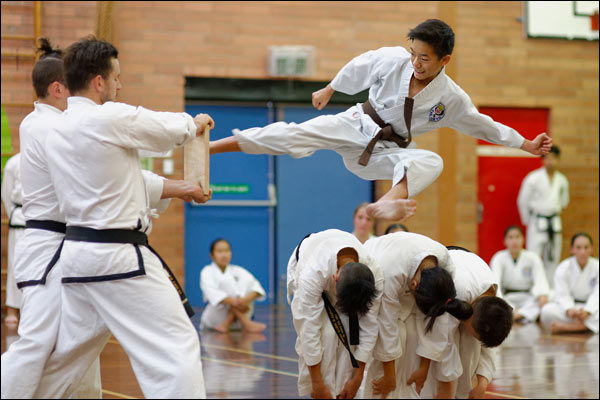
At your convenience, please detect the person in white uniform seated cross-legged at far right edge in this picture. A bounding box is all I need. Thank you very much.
[540,232,598,333]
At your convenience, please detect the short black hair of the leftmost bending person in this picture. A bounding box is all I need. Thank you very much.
[335,262,377,316]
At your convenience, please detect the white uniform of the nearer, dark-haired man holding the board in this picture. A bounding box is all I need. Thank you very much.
[34,96,206,398]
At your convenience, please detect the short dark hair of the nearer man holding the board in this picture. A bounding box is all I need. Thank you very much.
[64,35,119,94]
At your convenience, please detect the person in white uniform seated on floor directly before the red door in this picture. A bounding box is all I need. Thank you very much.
[490,225,550,323]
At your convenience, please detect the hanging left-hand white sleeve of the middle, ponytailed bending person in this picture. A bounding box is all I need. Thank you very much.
[373,279,404,362]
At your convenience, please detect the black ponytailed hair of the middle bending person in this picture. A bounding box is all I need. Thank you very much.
[415,267,473,332]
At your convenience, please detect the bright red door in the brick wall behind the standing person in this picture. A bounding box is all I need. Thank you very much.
[477,107,549,263]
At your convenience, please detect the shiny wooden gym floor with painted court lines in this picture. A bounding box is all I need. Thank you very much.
[2,305,599,399]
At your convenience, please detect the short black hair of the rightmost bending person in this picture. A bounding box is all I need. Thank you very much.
[471,296,513,347]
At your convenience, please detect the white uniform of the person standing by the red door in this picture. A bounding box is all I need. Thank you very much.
[517,167,569,285]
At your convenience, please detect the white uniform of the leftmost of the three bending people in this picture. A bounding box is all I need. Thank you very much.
[287,229,383,396]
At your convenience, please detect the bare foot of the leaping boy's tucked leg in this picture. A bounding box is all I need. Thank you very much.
[367,176,417,221]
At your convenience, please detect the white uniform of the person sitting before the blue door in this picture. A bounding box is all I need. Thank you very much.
[200,262,266,329]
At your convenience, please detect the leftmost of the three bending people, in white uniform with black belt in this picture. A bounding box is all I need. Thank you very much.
[287,229,383,399]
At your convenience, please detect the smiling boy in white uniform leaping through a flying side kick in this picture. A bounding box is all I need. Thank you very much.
[211,19,552,221]
